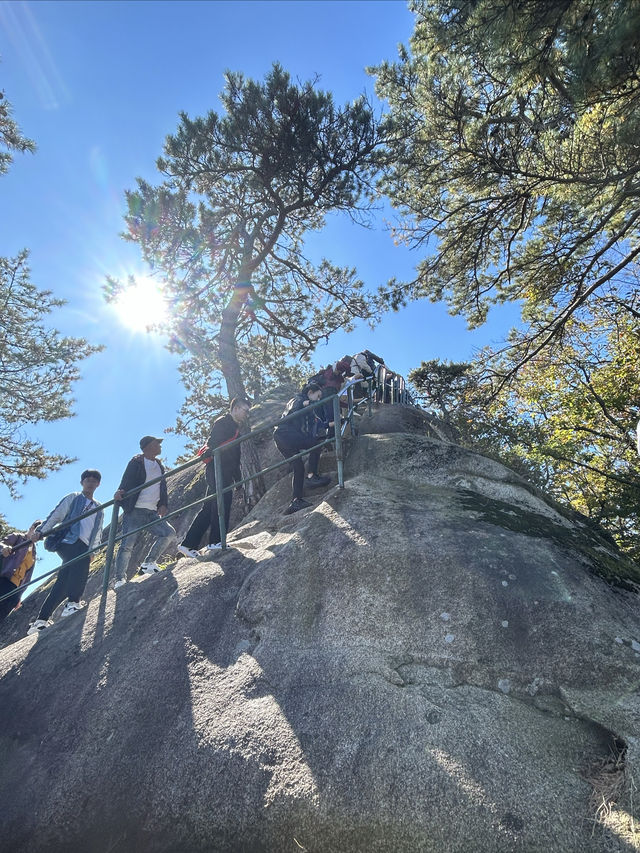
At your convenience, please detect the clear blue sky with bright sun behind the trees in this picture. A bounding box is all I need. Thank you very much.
[0,0,517,570]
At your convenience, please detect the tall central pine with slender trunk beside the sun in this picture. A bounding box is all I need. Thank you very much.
[108,64,382,416]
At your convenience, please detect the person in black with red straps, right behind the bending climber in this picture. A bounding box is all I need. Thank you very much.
[178,397,251,557]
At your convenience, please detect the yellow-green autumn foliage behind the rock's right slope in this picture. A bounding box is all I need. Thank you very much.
[409,320,640,559]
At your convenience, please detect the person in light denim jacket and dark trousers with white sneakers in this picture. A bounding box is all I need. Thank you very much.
[27,468,104,634]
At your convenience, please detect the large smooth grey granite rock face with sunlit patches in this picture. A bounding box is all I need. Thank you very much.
[0,407,640,853]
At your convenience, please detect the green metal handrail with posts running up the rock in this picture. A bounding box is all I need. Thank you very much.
[0,364,414,601]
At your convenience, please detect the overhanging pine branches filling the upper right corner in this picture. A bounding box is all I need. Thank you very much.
[377,0,640,379]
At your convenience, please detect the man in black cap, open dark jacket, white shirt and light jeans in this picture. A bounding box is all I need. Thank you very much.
[113,435,176,589]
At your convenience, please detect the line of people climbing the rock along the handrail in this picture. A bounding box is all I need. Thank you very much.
[0,350,384,634]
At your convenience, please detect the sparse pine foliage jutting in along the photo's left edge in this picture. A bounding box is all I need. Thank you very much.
[0,88,100,497]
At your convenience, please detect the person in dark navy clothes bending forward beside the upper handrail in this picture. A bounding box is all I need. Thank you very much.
[273,382,333,515]
